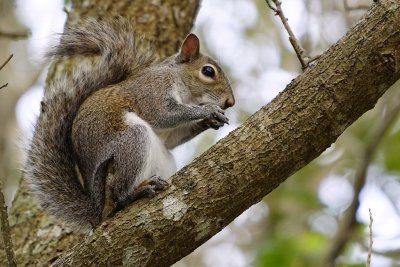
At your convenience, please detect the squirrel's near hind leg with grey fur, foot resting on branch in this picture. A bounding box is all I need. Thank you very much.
[110,123,172,214]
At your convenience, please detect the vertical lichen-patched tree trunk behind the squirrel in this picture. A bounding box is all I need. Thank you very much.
[0,0,199,266]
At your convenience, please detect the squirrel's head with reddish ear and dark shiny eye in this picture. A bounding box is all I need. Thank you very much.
[175,33,235,109]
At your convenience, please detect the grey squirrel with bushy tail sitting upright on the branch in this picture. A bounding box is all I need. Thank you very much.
[24,17,235,232]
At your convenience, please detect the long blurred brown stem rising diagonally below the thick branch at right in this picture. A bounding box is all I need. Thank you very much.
[326,99,400,266]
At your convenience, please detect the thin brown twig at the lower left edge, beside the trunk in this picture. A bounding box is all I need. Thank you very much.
[0,181,17,267]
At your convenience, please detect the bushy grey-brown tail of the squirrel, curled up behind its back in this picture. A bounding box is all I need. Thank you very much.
[24,18,154,230]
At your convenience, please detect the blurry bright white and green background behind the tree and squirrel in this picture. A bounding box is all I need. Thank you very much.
[0,0,400,267]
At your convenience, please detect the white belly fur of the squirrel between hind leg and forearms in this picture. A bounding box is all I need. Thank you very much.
[125,112,176,186]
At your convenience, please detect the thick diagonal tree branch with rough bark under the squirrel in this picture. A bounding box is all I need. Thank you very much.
[51,0,400,266]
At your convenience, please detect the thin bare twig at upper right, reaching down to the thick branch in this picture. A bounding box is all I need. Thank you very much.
[265,0,319,70]
